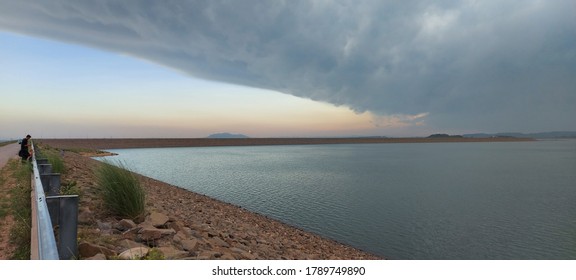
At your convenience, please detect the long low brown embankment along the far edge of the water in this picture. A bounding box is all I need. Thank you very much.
[37,137,535,150]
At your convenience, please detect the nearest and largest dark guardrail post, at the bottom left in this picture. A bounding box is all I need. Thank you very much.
[46,195,78,260]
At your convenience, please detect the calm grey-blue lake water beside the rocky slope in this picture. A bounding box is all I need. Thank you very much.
[99,140,576,260]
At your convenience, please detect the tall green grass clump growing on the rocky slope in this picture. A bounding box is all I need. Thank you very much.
[96,160,146,219]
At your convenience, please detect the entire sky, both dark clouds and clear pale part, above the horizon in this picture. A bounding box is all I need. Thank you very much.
[0,0,576,138]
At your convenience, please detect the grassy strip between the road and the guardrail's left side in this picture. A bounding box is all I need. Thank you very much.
[0,160,32,260]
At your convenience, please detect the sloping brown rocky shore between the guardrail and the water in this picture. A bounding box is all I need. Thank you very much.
[62,151,384,260]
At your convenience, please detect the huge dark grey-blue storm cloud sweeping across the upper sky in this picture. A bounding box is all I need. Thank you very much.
[0,0,576,130]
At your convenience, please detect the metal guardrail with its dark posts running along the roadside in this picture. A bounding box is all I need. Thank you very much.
[31,143,78,260]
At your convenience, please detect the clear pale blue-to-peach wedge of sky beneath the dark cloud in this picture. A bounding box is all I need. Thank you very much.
[0,33,390,138]
